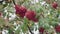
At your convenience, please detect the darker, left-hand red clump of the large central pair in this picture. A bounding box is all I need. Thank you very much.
[15,5,27,18]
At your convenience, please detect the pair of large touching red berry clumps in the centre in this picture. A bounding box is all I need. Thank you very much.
[15,5,38,22]
